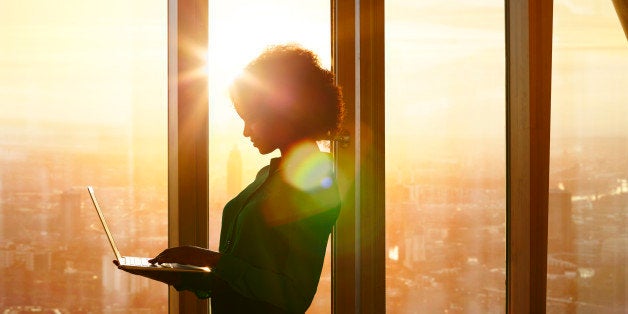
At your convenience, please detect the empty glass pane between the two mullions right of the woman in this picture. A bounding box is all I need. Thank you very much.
[386,0,506,313]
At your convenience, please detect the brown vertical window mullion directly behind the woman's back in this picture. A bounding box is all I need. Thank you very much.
[332,0,385,313]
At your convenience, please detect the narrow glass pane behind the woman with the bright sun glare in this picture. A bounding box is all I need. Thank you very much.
[208,0,331,313]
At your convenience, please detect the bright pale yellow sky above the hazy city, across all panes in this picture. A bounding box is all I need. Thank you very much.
[0,0,628,145]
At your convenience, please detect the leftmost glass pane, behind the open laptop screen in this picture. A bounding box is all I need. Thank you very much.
[0,0,168,313]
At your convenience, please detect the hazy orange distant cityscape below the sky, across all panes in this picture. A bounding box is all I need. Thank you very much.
[0,134,628,313]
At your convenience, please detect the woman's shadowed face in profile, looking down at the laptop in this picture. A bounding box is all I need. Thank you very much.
[236,105,296,155]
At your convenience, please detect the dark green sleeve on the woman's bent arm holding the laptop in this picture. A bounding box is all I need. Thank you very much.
[214,209,338,313]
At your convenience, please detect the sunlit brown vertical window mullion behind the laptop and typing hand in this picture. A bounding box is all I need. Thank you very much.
[168,0,209,313]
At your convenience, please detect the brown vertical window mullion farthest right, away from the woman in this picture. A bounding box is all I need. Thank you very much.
[506,0,553,313]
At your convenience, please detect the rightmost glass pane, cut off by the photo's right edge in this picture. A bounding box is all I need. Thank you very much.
[547,0,628,313]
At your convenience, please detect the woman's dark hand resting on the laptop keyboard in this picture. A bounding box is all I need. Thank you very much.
[149,245,221,268]
